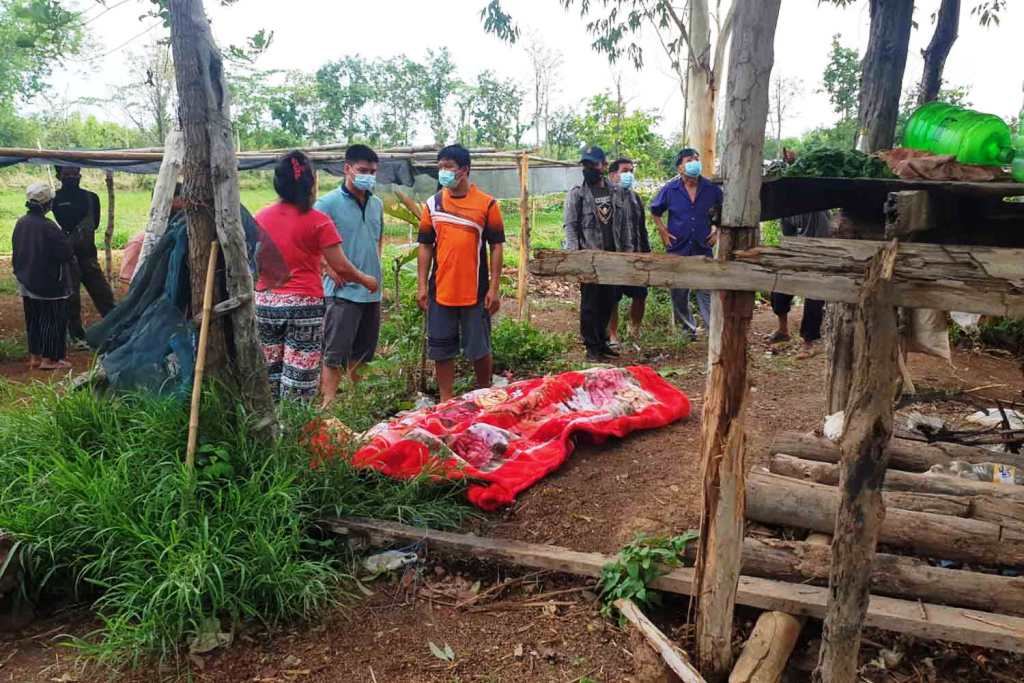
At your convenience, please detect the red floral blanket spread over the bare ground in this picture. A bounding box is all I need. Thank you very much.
[314,367,690,510]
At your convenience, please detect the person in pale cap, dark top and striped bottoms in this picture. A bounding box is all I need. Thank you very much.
[11,183,75,370]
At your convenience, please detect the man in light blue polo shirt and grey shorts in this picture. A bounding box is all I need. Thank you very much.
[314,144,384,408]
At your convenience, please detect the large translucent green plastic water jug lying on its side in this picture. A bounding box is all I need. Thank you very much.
[903,101,1014,166]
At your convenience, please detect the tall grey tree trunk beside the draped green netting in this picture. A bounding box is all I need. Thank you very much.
[170,0,276,435]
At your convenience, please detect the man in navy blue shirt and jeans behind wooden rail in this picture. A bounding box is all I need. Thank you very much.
[650,147,722,336]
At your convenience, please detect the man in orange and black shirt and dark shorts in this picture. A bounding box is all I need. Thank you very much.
[418,144,505,401]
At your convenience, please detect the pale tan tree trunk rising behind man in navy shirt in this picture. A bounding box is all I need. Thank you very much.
[686,0,725,176]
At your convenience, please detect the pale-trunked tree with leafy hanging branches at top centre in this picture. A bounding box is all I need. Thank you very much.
[481,0,733,171]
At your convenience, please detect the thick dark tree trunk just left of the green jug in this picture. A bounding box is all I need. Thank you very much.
[857,0,913,152]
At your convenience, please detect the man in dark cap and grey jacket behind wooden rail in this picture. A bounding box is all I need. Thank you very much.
[565,145,634,360]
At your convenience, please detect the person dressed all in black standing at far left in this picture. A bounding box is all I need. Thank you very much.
[53,166,114,343]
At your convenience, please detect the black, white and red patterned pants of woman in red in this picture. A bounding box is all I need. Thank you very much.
[256,292,324,400]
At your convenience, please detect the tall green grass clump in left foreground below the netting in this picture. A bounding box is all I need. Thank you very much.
[0,386,468,664]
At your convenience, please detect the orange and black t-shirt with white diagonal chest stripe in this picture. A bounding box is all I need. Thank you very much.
[419,185,505,306]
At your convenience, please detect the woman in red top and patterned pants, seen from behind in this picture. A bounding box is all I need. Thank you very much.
[256,152,377,399]
